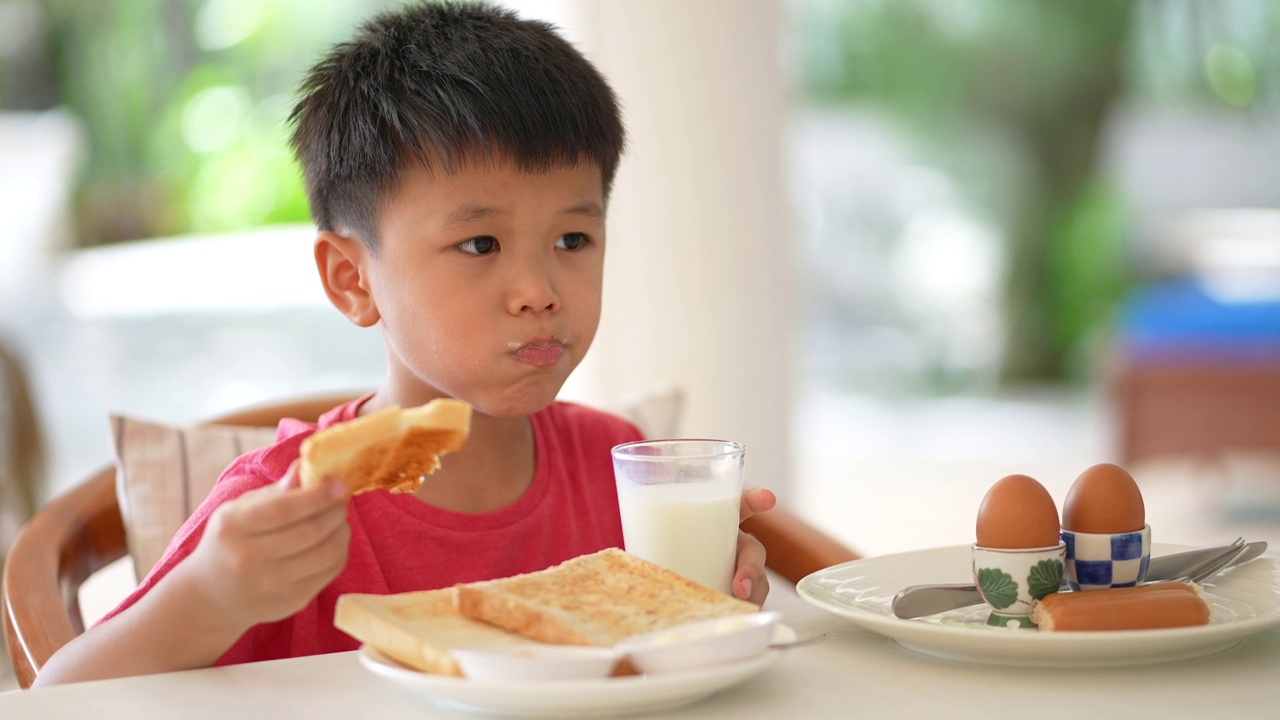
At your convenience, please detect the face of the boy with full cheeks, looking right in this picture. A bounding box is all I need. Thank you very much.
[335,156,604,416]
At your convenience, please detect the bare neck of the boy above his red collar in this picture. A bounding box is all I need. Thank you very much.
[360,396,535,514]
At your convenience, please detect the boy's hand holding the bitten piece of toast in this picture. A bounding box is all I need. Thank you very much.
[182,462,351,629]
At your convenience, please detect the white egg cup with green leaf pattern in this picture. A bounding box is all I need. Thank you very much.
[973,542,1066,617]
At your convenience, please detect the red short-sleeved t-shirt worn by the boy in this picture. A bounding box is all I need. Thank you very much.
[104,397,641,665]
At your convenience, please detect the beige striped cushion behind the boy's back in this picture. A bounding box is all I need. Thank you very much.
[111,387,684,579]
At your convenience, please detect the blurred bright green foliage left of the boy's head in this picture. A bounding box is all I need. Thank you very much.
[0,0,392,245]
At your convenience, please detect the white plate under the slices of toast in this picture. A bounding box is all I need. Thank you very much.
[358,625,796,717]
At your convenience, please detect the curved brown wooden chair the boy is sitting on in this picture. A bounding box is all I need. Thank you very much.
[3,395,858,688]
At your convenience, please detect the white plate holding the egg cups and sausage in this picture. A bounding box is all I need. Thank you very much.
[796,543,1280,667]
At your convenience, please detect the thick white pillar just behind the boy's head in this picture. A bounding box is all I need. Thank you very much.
[575,0,795,495]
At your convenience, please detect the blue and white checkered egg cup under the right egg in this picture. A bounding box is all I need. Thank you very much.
[1062,525,1151,591]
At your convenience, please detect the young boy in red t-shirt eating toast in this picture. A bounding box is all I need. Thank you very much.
[36,4,774,684]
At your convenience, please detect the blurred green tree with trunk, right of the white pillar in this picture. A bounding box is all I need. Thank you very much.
[797,0,1280,383]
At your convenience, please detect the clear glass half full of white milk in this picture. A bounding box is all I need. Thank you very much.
[613,439,746,594]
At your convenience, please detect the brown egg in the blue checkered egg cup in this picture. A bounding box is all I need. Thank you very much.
[1062,462,1147,533]
